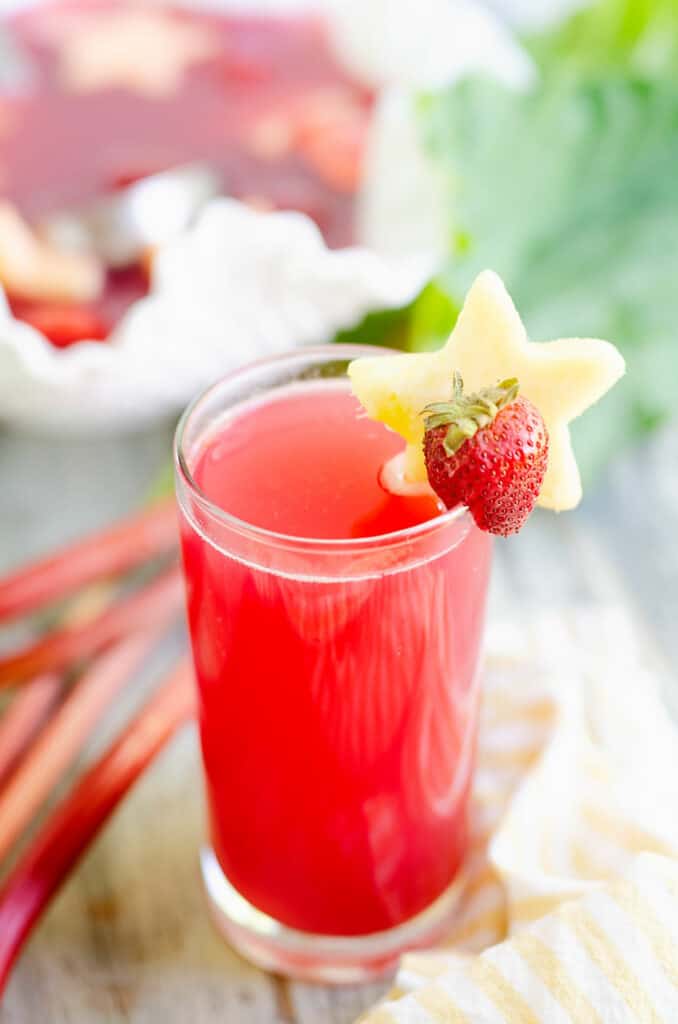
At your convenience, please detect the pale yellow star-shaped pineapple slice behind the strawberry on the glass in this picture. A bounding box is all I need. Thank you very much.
[349,270,625,511]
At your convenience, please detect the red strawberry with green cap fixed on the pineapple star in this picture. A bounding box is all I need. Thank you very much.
[424,373,549,537]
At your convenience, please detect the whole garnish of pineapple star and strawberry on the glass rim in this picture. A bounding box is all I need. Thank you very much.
[348,270,625,535]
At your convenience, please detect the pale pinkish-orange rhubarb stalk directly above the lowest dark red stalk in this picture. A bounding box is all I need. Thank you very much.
[0,630,170,860]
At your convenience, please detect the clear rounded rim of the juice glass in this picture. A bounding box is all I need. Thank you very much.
[173,343,469,552]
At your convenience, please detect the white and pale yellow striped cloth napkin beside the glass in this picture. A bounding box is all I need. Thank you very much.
[361,609,678,1024]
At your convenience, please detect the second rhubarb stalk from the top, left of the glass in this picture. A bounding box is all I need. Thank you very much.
[0,567,183,686]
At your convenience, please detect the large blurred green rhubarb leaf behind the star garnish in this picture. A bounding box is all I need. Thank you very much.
[410,75,678,483]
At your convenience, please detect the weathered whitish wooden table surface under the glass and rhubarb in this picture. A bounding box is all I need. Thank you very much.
[0,417,678,1024]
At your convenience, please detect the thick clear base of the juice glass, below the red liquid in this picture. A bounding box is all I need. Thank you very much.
[201,849,460,985]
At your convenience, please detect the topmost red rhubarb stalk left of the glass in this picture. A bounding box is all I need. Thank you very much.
[0,501,177,621]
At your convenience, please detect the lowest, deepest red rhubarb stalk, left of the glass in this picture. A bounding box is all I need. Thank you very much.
[0,663,194,995]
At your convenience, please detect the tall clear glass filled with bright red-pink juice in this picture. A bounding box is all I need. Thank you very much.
[176,346,491,981]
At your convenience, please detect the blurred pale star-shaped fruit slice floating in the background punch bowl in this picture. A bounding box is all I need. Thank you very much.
[59,8,215,99]
